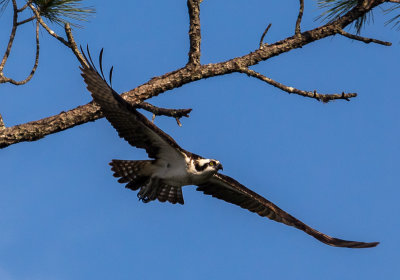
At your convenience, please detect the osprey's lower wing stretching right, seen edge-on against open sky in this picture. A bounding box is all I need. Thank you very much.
[197,173,379,248]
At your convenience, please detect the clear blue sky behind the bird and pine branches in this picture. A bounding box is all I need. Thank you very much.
[0,0,400,280]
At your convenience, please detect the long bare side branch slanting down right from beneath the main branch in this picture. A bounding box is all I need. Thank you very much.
[234,66,357,103]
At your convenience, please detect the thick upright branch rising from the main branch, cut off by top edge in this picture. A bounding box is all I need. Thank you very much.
[187,0,201,66]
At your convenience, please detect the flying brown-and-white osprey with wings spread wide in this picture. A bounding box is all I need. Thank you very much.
[80,49,379,248]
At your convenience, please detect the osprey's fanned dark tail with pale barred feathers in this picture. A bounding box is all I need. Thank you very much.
[110,159,184,204]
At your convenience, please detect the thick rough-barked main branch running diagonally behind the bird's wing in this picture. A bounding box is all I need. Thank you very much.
[0,0,385,148]
